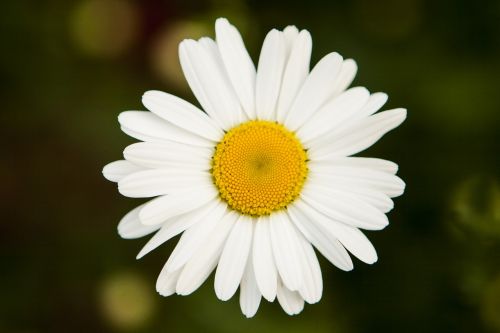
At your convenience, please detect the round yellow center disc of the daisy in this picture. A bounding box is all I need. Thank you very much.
[212,120,308,216]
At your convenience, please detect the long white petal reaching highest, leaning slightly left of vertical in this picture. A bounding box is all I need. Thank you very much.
[215,18,255,119]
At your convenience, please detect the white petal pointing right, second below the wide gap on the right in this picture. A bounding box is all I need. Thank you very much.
[308,163,405,197]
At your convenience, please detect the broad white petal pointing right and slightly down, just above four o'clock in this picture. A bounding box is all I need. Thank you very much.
[301,186,389,230]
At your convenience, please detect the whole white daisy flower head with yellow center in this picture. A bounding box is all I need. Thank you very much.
[103,19,406,317]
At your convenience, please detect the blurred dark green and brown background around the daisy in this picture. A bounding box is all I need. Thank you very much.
[0,0,500,333]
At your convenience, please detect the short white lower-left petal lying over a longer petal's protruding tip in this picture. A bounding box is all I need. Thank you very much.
[139,185,218,225]
